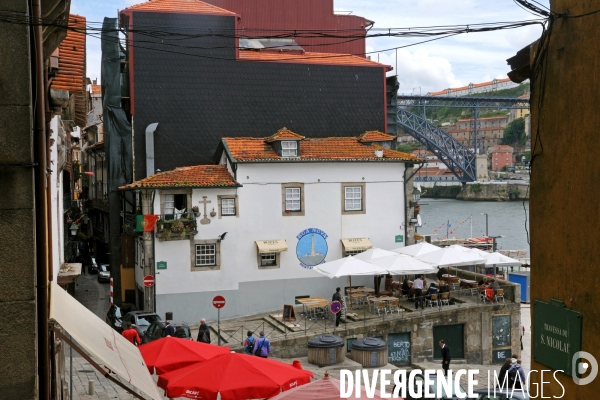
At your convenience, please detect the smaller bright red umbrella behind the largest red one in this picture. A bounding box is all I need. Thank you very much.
[140,336,231,375]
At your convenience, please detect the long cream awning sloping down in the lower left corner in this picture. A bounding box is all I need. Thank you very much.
[50,282,163,400]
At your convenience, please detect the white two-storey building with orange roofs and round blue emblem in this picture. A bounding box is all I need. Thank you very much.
[126,128,420,322]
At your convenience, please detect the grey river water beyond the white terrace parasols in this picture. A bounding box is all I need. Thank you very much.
[418,198,529,255]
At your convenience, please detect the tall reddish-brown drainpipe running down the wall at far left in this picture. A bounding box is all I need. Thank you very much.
[30,0,50,399]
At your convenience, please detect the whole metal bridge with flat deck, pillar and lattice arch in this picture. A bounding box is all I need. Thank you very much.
[396,96,529,182]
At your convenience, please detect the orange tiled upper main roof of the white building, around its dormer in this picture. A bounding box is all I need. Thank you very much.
[223,133,424,162]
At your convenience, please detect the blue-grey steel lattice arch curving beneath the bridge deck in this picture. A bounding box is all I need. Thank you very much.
[397,107,477,183]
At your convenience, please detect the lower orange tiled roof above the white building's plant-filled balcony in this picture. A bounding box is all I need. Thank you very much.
[119,164,241,189]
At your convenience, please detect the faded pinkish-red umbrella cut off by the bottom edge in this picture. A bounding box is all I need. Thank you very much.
[270,372,394,400]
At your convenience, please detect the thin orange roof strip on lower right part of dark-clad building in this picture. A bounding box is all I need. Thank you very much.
[239,50,392,71]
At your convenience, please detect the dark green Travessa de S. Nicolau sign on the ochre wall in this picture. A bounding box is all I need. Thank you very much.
[533,299,581,376]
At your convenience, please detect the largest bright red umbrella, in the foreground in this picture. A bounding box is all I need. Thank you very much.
[158,353,314,400]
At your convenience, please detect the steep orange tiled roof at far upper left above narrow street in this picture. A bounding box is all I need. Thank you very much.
[51,14,87,126]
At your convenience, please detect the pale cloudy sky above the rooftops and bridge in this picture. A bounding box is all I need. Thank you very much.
[71,0,549,94]
